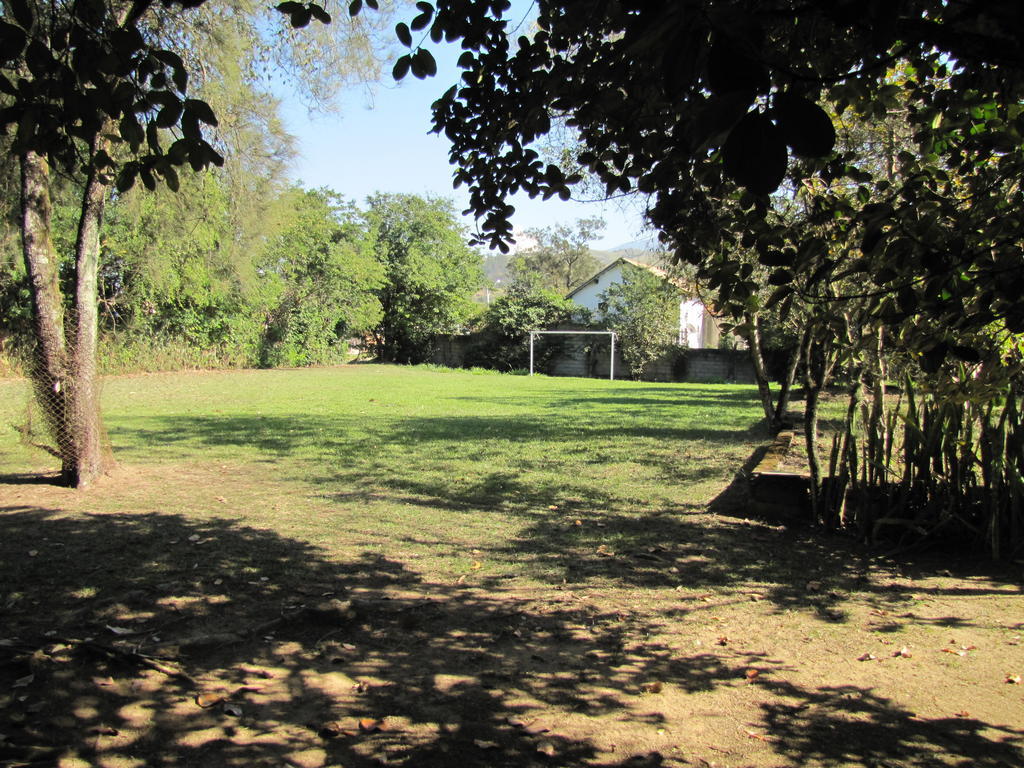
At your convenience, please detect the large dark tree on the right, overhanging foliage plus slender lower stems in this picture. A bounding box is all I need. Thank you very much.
[362,0,1024,553]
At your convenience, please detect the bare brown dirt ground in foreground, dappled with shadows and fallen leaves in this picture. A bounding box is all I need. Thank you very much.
[0,467,1024,768]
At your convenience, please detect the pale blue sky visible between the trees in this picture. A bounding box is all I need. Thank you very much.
[283,2,649,249]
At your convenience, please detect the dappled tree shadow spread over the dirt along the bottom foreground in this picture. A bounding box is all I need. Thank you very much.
[0,507,1024,768]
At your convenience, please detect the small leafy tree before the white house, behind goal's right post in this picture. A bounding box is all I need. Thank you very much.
[599,268,679,380]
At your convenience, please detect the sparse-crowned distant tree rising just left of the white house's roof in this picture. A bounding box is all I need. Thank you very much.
[511,218,604,294]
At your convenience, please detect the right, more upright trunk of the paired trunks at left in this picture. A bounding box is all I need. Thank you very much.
[70,142,113,488]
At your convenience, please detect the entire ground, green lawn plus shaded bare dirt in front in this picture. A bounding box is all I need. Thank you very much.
[0,366,1024,768]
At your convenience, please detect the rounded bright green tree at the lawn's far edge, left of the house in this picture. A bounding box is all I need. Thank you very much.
[368,194,483,362]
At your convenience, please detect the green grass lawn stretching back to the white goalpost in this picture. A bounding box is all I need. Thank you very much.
[0,366,764,582]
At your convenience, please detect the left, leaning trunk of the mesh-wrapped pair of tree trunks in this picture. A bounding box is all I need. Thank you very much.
[19,151,76,481]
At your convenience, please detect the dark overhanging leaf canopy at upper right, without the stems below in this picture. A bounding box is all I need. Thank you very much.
[372,0,1024,367]
